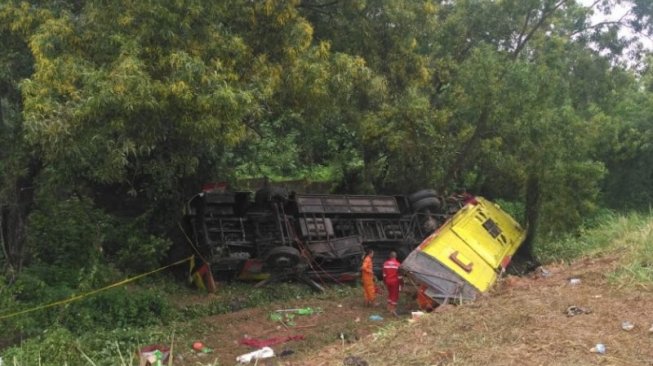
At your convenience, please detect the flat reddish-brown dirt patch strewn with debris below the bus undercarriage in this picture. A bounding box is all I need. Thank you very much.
[174,289,414,366]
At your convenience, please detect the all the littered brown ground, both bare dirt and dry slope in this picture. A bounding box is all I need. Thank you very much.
[169,257,653,366]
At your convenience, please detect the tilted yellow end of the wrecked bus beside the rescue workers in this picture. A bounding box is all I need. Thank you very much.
[401,197,526,304]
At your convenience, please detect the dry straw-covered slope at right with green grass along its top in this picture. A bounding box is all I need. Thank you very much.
[299,214,653,365]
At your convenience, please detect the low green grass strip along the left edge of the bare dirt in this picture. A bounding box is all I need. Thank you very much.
[0,283,359,366]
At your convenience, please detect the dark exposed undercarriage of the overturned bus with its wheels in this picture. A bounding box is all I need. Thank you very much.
[186,185,465,289]
